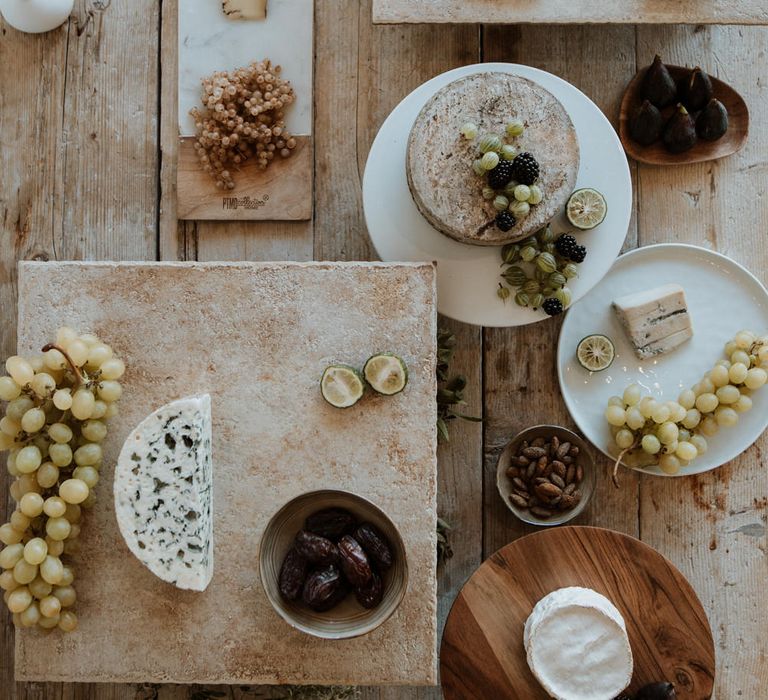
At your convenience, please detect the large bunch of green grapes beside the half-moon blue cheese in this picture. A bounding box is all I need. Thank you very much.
[0,327,125,632]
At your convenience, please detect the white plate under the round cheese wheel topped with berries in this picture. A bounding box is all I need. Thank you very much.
[363,63,632,326]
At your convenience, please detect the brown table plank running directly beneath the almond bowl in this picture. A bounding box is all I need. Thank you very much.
[483,26,637,556]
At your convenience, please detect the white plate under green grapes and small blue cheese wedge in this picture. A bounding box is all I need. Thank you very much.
[557,244,768,476]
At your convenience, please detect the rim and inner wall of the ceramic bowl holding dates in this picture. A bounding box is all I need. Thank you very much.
[259,489,408,639]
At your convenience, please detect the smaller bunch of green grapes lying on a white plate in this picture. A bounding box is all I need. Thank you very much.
[605,331,768,474]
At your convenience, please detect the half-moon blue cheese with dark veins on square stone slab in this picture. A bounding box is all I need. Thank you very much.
[114,395,213,591]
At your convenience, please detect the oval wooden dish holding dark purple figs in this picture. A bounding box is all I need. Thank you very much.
[619,66,749,165]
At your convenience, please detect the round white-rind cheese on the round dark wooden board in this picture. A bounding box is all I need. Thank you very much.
[523,586,633,700]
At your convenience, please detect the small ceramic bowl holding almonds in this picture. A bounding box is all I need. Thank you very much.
[496,425,597,527]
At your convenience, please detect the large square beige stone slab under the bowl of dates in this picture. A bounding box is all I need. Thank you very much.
[16,262,437,685]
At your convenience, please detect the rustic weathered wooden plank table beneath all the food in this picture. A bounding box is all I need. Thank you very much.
[0,0,768,700]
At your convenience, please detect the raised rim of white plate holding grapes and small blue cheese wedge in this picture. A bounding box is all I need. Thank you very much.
[557,243,768,478]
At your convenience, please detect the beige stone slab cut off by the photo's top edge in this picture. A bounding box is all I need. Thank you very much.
[373,0,768,24]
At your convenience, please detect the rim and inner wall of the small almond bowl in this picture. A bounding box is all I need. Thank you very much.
[496,424,597,527]
